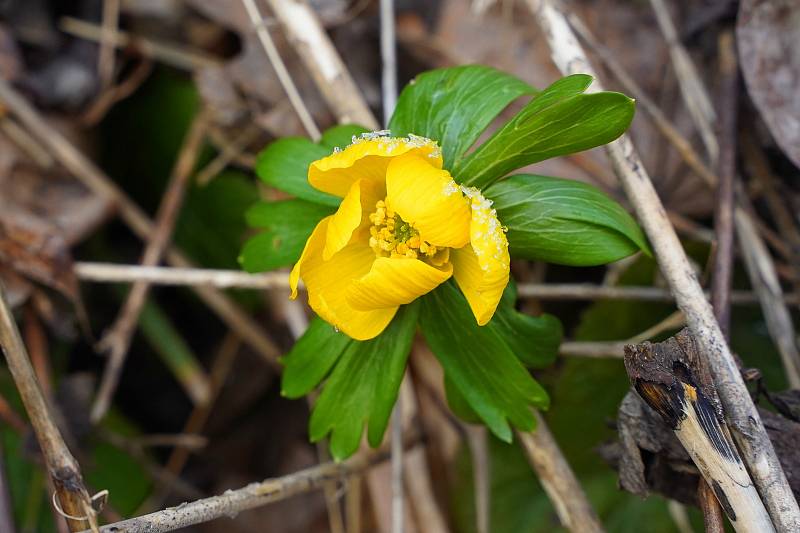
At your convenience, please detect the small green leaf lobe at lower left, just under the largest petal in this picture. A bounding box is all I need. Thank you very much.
[281,317,355,398]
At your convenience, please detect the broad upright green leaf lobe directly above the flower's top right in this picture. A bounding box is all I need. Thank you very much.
[389,65,535,168]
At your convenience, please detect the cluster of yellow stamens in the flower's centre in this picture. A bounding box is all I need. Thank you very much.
[369,200,450,266]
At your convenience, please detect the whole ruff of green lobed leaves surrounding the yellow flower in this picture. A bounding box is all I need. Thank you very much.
[240,65,649,459]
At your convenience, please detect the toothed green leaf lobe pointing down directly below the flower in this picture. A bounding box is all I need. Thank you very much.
[309,303,419,461]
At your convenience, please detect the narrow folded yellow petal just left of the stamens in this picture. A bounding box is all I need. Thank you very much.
[322,180,386,261]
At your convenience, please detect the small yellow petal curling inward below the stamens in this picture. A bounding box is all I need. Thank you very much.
[347,257,453,311]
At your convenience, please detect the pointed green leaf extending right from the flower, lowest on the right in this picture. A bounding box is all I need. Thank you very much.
[485,174,651,266]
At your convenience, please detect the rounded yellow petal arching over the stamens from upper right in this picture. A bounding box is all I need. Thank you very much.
[386,154,470,248]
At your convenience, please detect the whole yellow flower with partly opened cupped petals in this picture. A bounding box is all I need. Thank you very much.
[290,132,509,340]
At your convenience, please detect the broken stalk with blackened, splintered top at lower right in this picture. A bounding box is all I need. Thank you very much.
[625,330,774,533]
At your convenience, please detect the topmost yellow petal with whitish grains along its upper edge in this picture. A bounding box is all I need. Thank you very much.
[308,133,442,197]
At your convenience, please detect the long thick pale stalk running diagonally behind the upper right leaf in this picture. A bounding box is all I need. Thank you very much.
[528,0,800,532]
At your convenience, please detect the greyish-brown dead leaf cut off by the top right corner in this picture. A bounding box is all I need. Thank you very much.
[736,0,800,167]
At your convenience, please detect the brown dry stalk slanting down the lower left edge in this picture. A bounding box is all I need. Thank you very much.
[0,286,97,531]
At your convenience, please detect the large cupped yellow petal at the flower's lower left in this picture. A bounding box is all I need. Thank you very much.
[290,217,397,340]
